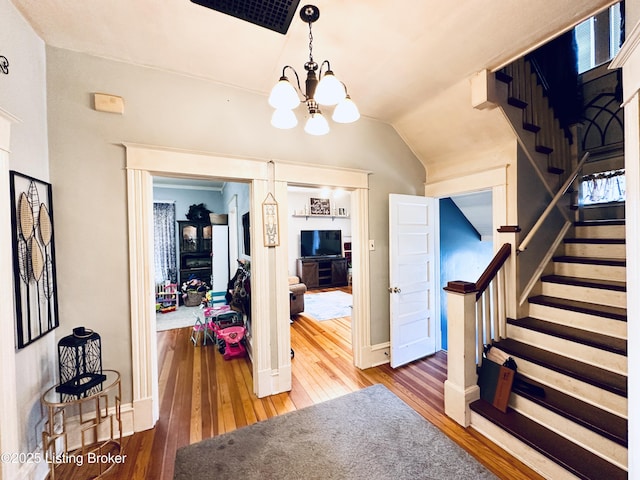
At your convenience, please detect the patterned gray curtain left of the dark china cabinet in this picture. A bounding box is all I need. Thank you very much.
[153,202,178,284]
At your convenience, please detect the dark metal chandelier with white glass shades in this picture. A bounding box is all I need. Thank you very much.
[269,5,360,135]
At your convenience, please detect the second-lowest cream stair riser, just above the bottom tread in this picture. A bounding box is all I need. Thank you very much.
[509,394,628,469]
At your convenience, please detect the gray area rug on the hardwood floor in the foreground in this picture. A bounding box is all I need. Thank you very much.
[174,385,497,480]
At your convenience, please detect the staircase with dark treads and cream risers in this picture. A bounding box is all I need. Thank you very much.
[470,220,628,480]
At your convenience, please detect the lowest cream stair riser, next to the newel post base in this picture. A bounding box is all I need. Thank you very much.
[471,412,578,480]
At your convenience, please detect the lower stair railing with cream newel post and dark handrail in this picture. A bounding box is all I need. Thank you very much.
[444,243,512,427]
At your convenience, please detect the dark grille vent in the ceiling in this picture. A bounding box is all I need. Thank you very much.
[191,0,300,35]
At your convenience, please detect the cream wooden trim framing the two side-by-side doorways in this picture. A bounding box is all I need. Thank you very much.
[124,143,370,424]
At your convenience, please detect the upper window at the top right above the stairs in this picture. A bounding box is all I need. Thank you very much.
[575,3,621,73]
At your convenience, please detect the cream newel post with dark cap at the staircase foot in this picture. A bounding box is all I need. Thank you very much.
[444,281,480,427]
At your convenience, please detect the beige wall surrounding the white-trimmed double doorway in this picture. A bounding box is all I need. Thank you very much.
[47,48,425,402]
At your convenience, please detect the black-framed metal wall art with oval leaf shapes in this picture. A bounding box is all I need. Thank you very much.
[9,170,60,349]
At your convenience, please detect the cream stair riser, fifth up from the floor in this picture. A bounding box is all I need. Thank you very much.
[529,303,627,339]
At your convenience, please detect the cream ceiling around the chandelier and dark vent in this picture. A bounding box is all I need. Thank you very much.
[11,0,615,165]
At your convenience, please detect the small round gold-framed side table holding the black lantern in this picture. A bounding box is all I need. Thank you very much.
[41,370,126,480]
